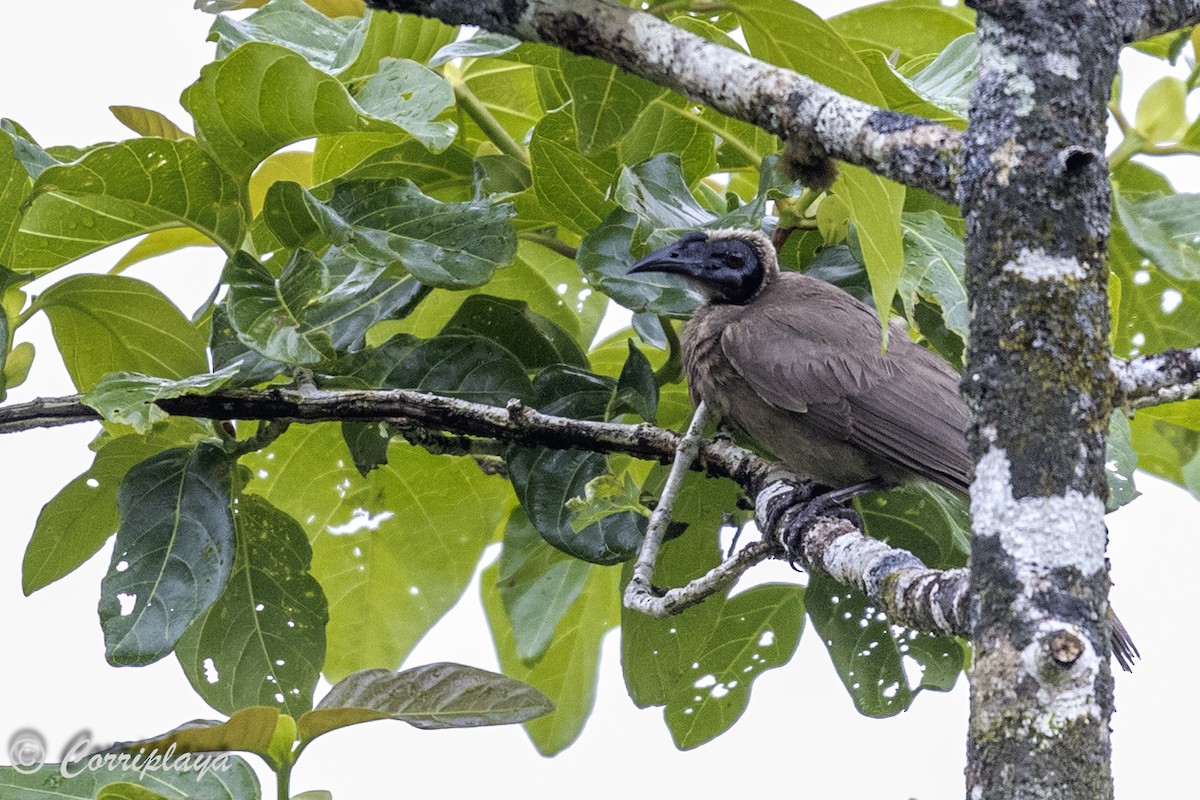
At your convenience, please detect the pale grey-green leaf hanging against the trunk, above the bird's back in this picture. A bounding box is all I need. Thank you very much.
[898,211,971,342]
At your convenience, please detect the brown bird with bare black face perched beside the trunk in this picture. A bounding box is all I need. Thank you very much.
[629,228,1140,672]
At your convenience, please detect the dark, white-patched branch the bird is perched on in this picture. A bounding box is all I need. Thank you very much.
[0,385,965,633]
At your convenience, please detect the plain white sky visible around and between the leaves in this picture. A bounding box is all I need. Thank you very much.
[0,0,1200,800]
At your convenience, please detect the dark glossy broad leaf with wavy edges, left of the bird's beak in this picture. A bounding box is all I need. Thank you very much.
[329,180,516,289]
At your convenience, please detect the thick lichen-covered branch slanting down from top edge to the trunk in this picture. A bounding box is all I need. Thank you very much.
[367,0,962,203]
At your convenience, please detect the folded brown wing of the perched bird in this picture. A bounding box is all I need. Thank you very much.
[721,275,973,489]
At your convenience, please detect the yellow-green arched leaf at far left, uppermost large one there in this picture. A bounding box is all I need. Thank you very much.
[12,138,245,272]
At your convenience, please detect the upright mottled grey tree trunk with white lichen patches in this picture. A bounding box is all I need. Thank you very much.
[960,0,1121,800]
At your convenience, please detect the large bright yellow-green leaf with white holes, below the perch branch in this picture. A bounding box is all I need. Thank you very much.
[242,425,512,680]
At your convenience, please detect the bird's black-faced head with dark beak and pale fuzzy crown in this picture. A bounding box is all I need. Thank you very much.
[629,228,779,305]
